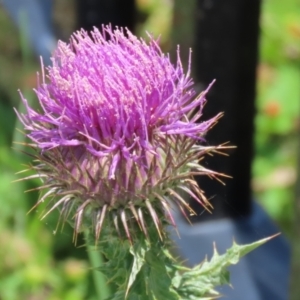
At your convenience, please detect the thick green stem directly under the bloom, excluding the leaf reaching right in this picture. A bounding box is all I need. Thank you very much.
[98,216,178,300]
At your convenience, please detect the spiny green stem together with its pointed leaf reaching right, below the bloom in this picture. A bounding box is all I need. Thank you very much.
[90,216,270,300]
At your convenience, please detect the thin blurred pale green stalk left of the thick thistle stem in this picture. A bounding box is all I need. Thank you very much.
[84,231,111,300]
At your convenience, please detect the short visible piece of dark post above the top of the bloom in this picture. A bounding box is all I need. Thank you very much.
[77,0,135,31]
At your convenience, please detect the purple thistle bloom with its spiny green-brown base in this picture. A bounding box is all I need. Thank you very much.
[17,27,220,239]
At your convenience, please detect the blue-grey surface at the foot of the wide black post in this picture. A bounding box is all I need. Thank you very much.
[171,203,290,300]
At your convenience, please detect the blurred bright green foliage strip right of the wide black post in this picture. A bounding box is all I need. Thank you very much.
[253,0,300,235]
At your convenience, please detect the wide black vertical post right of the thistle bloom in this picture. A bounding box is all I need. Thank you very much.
[193,0,260,220]
